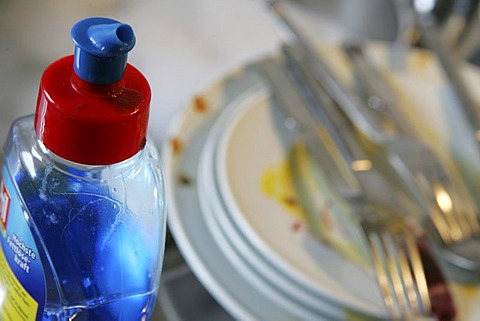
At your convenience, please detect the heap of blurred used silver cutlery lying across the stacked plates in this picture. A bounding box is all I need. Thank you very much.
[258,2,480,320]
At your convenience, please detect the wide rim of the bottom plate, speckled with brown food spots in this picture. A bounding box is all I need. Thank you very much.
[162,63,321,320]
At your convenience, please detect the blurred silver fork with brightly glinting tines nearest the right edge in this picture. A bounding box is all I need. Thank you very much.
[270,1,480,271]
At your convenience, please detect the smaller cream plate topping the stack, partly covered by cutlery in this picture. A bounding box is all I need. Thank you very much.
[200,83,383,314]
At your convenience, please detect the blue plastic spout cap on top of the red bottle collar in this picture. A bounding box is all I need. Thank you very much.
[71,17,135,85]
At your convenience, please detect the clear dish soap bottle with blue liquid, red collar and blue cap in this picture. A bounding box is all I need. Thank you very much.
[0,18,166,321]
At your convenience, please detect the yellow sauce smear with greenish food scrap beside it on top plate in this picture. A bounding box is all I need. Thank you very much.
[261,142,367,266]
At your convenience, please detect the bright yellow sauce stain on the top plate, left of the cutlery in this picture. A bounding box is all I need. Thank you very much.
[261,160,305,221]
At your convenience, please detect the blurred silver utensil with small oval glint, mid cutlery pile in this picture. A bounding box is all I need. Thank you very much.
[283,46,413,215]
